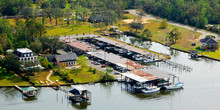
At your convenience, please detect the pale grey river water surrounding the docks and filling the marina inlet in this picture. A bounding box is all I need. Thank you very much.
[0,36,220,110]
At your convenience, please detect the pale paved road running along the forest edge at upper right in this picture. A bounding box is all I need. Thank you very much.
[127,10,220,39]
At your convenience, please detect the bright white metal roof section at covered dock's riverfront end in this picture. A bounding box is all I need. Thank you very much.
[121,72,148,83]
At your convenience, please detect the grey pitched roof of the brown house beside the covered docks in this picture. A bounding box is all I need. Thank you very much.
[56,53,78,62]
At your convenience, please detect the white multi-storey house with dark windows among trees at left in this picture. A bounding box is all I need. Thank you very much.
[15,48,38,62]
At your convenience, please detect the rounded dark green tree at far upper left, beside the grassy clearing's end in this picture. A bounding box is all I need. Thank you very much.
[21,7,33,22]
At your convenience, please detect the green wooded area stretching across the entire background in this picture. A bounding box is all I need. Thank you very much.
[0,0,220,54]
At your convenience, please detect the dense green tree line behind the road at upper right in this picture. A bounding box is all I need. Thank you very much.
[139,0,220,28]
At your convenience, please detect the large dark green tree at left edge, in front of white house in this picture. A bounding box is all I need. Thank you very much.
[0,55,22,73]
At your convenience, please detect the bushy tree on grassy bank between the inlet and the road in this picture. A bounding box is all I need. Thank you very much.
[168,28,181,43]
